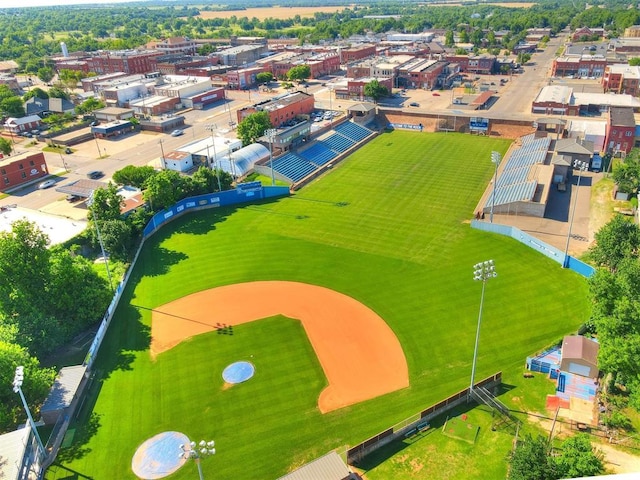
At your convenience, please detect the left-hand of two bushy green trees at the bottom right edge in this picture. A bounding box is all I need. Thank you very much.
[507,434,559,480]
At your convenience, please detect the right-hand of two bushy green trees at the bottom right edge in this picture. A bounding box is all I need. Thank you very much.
[554,434,605,478]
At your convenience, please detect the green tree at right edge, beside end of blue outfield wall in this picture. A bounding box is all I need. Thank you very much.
[588,215,640,272]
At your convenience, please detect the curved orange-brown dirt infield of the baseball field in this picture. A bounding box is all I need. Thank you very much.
[151,281,409,413]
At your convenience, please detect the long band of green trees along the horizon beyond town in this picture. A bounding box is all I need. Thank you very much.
[0,0,640,74]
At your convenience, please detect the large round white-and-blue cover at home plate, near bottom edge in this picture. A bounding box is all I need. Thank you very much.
[131,432,189,480]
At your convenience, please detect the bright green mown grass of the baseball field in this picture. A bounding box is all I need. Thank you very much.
[47,132,589,480]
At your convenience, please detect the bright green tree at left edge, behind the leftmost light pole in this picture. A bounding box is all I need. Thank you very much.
[0,341,56,432]
